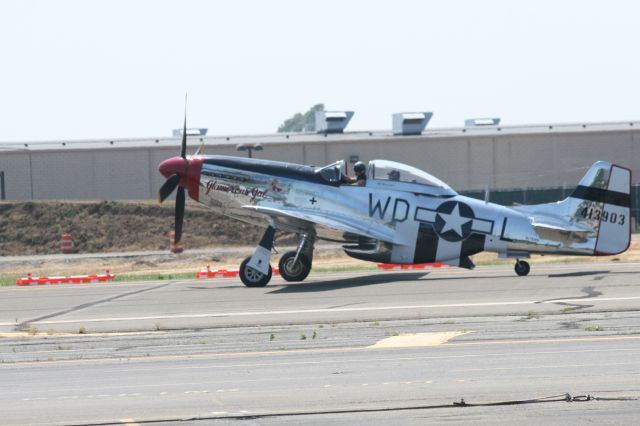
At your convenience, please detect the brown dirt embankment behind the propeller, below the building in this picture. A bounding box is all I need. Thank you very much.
[0,201,270,256]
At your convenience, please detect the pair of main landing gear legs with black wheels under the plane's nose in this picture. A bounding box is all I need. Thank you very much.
[240,226,315,287]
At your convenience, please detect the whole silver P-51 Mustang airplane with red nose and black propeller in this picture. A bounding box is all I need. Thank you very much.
[158,120,631,287]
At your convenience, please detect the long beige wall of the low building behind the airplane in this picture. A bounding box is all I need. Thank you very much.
[0,129,640,200]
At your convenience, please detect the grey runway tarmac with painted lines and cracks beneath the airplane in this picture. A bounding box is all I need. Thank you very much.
[0,262,640,424]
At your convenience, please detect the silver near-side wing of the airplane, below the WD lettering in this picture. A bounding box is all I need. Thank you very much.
[242,205,394,243]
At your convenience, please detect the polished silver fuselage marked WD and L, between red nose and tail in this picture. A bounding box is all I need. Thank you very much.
[192,156,597,263]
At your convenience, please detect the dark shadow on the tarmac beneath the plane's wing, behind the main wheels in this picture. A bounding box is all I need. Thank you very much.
[269,272,429,294]
